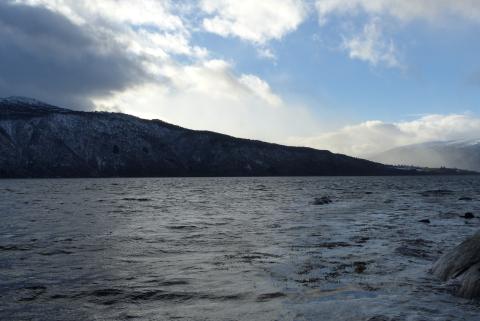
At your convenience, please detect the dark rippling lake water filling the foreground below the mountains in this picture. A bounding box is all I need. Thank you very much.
[0,177,480,321]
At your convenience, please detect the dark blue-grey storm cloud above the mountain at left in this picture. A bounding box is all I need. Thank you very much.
[0,3,148,109]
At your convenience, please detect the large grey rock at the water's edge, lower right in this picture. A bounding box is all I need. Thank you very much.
[432,232,480,299]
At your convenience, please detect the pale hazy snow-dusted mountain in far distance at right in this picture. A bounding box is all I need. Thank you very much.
[368,140,480,171]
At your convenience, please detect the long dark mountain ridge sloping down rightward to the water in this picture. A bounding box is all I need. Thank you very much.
[0,97,472,178]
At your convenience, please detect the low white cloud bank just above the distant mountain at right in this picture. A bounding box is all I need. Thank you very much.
[290,114,480,157]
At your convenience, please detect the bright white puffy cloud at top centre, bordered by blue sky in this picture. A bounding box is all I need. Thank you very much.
[201,0,307,44]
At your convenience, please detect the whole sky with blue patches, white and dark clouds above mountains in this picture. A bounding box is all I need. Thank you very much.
[0,0,480,156]
